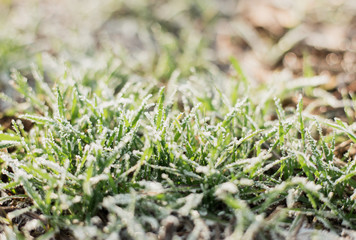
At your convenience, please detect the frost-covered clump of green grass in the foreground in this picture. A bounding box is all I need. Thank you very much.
[0,60,356,239]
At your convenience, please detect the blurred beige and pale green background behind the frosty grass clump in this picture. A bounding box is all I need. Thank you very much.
[0,0,356,111]
